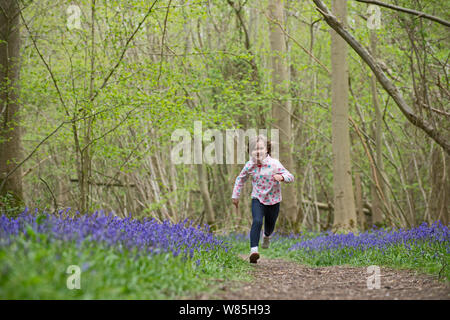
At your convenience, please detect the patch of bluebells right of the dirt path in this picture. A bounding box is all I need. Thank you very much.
[288,221,450,252]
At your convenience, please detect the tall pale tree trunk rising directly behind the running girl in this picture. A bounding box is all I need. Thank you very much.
[268,0,300,232]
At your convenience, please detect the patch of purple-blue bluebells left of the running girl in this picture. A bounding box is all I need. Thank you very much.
[0,209,230,258]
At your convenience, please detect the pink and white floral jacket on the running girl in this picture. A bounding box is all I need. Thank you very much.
[232,155,294,205]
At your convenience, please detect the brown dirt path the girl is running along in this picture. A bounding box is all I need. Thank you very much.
[194,257,450,300]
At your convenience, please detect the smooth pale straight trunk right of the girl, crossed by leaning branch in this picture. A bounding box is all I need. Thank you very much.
[331,0,356,230]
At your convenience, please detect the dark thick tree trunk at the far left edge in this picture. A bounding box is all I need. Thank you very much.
[0,0,23,207]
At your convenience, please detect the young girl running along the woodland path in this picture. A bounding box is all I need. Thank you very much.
[232,135,294,263]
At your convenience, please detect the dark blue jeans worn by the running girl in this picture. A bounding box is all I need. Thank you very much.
[250,199,280,248]
